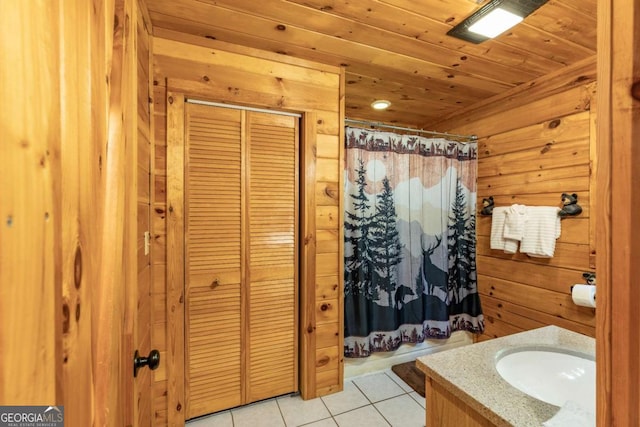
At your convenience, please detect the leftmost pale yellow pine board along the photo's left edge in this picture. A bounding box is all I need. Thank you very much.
[0,2,67,405]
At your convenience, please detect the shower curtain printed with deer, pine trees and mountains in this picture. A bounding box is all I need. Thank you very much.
[344,127,484,357]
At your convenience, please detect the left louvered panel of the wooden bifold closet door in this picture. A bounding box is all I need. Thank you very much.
[185,104,244,418]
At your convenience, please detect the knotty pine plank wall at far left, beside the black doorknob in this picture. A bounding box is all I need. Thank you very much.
[0,0,150,426]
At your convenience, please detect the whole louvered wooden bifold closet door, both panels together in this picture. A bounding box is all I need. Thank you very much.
[185,104,298,419]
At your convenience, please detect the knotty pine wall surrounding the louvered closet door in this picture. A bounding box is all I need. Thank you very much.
[152,29,344,425]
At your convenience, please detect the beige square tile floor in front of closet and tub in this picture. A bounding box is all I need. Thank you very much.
[187,370,425,427]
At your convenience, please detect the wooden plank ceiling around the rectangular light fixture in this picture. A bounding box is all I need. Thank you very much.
[147,0,597,128]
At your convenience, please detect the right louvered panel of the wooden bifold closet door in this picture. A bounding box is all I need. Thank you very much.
[246,112,298,402]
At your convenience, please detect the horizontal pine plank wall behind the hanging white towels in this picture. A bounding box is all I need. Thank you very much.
[439,58,596,339]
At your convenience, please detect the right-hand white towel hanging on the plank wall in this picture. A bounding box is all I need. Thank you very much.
[520,206,560,258]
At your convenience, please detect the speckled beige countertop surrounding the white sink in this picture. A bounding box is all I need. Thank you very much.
[417,326,595,427]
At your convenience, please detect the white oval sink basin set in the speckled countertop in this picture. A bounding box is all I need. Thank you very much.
[496,348,596,414]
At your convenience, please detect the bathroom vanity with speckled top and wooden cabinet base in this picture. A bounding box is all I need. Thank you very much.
[416,326,595,427]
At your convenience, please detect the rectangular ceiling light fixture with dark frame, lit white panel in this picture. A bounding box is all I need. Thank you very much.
[447,0,547,43]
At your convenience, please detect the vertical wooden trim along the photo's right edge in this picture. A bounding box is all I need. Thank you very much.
[596,0,640,427]
